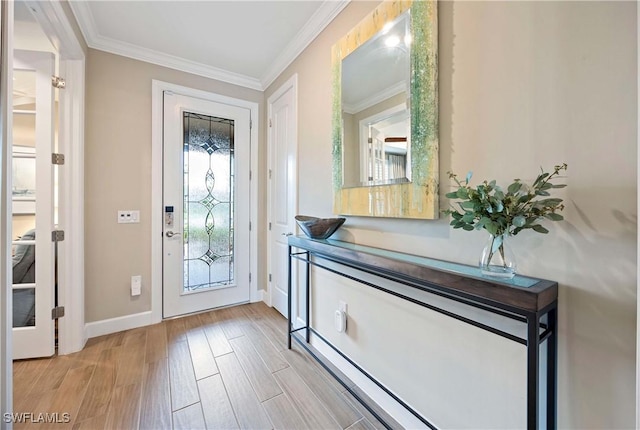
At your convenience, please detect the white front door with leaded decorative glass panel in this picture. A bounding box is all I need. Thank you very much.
[163,92,251,318]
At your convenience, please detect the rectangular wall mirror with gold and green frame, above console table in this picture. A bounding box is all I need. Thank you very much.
[332,1,438,219]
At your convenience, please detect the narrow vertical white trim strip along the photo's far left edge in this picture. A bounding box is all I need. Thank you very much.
[0,1,13,420]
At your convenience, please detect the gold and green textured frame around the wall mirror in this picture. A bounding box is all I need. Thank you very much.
[331,0,439,219]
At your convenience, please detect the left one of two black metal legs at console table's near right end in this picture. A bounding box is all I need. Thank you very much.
[527,312,540,430]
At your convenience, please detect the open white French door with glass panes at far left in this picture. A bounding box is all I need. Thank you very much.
[12,50,55,359]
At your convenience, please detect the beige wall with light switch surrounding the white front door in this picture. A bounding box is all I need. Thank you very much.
[85,49,264,322]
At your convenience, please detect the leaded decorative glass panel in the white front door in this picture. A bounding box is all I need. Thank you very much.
[183,112,234,293]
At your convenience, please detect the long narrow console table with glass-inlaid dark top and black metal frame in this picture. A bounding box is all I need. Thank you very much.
[288,236,558,430]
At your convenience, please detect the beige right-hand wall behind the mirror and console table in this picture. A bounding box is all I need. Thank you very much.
[265,2,637,428]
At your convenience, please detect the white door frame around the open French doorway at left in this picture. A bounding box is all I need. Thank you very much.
[0,1,86,416]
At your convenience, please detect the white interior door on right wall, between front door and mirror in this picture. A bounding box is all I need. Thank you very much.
[268,77,297,317]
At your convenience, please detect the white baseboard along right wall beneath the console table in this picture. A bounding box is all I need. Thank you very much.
[308,336,428,429]
